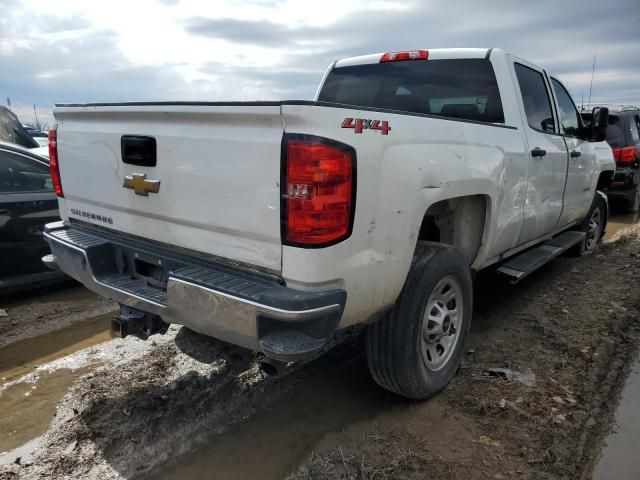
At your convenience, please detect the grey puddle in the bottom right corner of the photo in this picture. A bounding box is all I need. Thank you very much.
[593,359,640,480]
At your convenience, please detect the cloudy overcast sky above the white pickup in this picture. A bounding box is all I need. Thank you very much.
[0,0,640,122]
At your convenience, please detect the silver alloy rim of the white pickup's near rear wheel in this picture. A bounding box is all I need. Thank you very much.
[421,276,464,371]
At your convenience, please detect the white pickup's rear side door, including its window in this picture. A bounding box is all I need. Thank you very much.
[511,59,568,245]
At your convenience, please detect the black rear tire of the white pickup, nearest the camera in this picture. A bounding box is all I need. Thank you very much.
[366,242,473,399]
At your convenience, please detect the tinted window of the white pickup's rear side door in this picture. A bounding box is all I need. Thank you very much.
[515,63,556,133]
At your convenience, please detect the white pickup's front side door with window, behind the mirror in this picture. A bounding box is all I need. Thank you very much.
[551,78,600,225]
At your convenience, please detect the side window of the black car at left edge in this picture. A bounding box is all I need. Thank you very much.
[0,150,53,193]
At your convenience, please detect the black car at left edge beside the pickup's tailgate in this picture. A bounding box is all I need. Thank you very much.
[0,141,65,295]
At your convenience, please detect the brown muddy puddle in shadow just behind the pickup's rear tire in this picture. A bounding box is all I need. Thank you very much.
[152,358,399,480]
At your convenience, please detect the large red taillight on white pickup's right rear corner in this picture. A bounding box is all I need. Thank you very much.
[282,136,356,247]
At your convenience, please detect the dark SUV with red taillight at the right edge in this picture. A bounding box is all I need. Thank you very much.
[582,107,640,212]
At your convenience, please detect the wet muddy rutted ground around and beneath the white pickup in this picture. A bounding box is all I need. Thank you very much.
[0,222,640,480]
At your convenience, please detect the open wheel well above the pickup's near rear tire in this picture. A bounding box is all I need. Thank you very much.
[418,195,487,265]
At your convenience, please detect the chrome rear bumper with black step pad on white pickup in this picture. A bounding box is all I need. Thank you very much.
[44,222,346,361]
